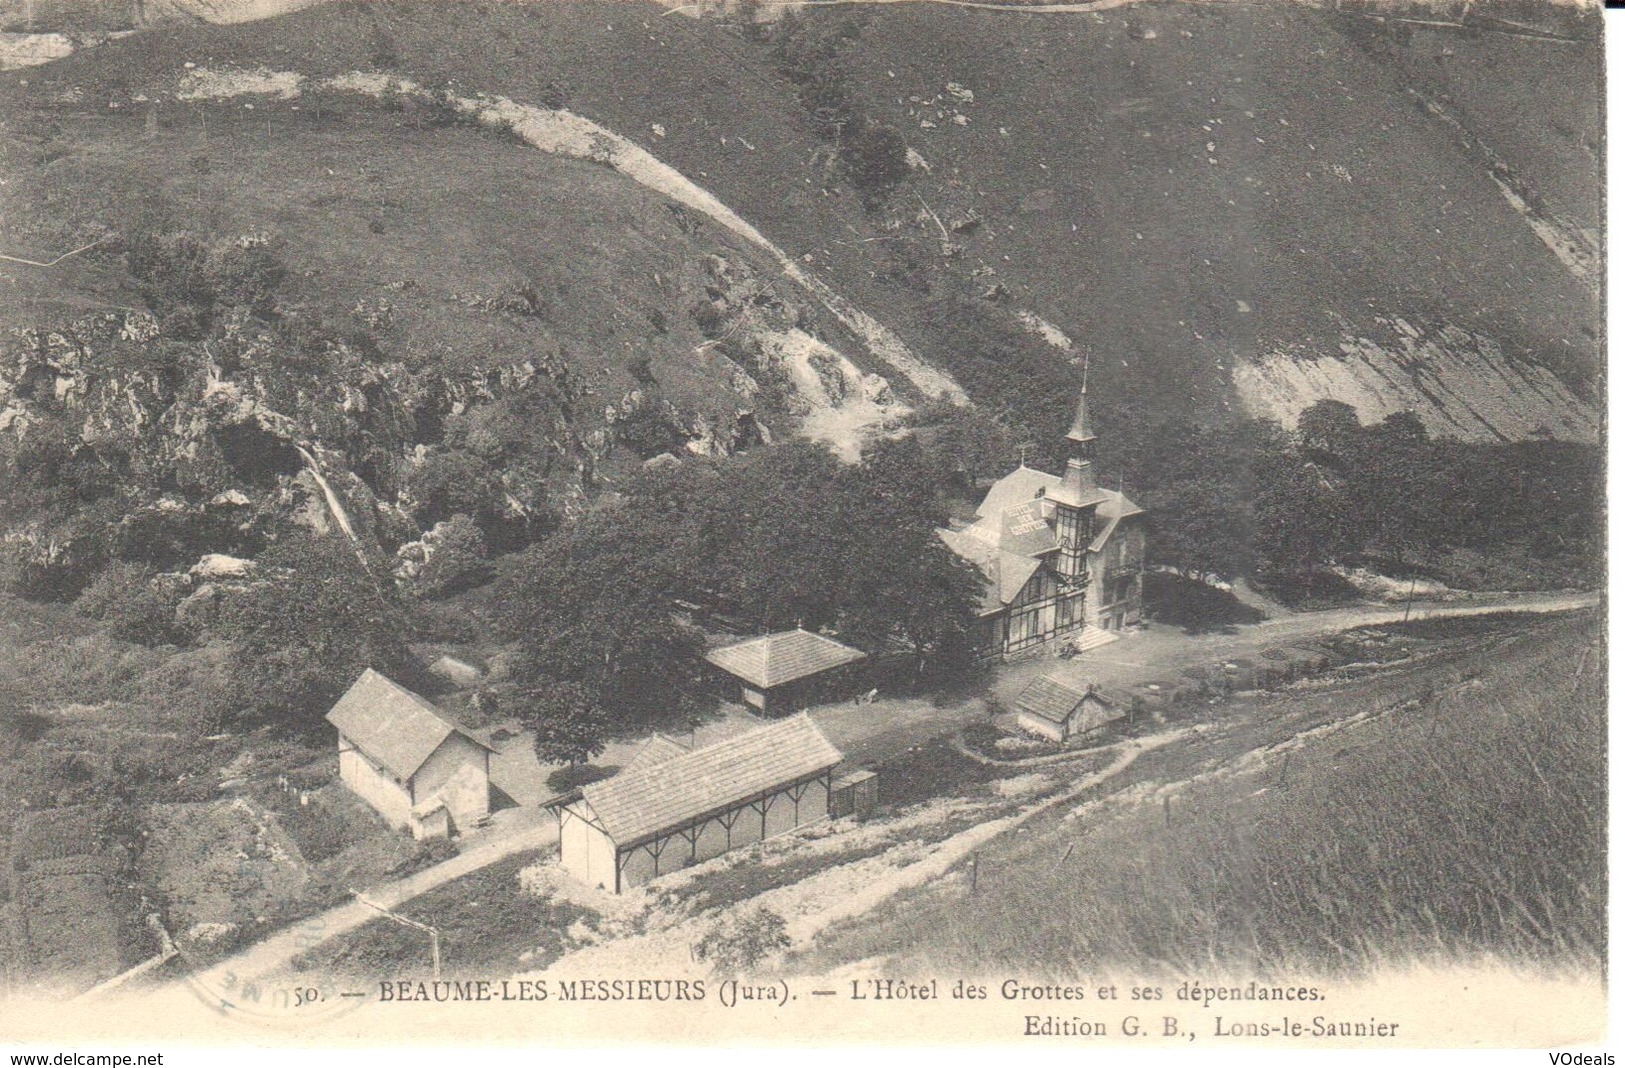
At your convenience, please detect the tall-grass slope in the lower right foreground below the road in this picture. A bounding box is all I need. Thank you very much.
[801,614,1606,977]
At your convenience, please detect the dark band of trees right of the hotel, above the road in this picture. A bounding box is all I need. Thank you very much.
[1125,400,1602,585]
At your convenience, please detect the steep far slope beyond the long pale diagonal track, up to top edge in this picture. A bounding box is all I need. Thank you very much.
[3,2,1601,437]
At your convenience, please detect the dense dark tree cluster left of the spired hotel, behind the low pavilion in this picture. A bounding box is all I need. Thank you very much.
[499,439,980,759]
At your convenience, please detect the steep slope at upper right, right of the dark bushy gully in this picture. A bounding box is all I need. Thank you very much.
[809,5,1601,439]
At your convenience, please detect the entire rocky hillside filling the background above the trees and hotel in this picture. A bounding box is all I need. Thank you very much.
[0,0,1601,581]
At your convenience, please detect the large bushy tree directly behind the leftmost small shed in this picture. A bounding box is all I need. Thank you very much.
[213,530,416,728]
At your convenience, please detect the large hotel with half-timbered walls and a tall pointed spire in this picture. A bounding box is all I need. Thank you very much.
[938,378,1146,655]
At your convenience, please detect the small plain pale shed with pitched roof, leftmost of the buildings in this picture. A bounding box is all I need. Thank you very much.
[327,668,494,839]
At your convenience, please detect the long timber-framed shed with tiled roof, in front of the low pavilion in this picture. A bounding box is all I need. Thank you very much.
[553,715,842,894]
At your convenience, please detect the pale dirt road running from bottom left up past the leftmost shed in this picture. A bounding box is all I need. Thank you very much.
[163,808,559,995]
